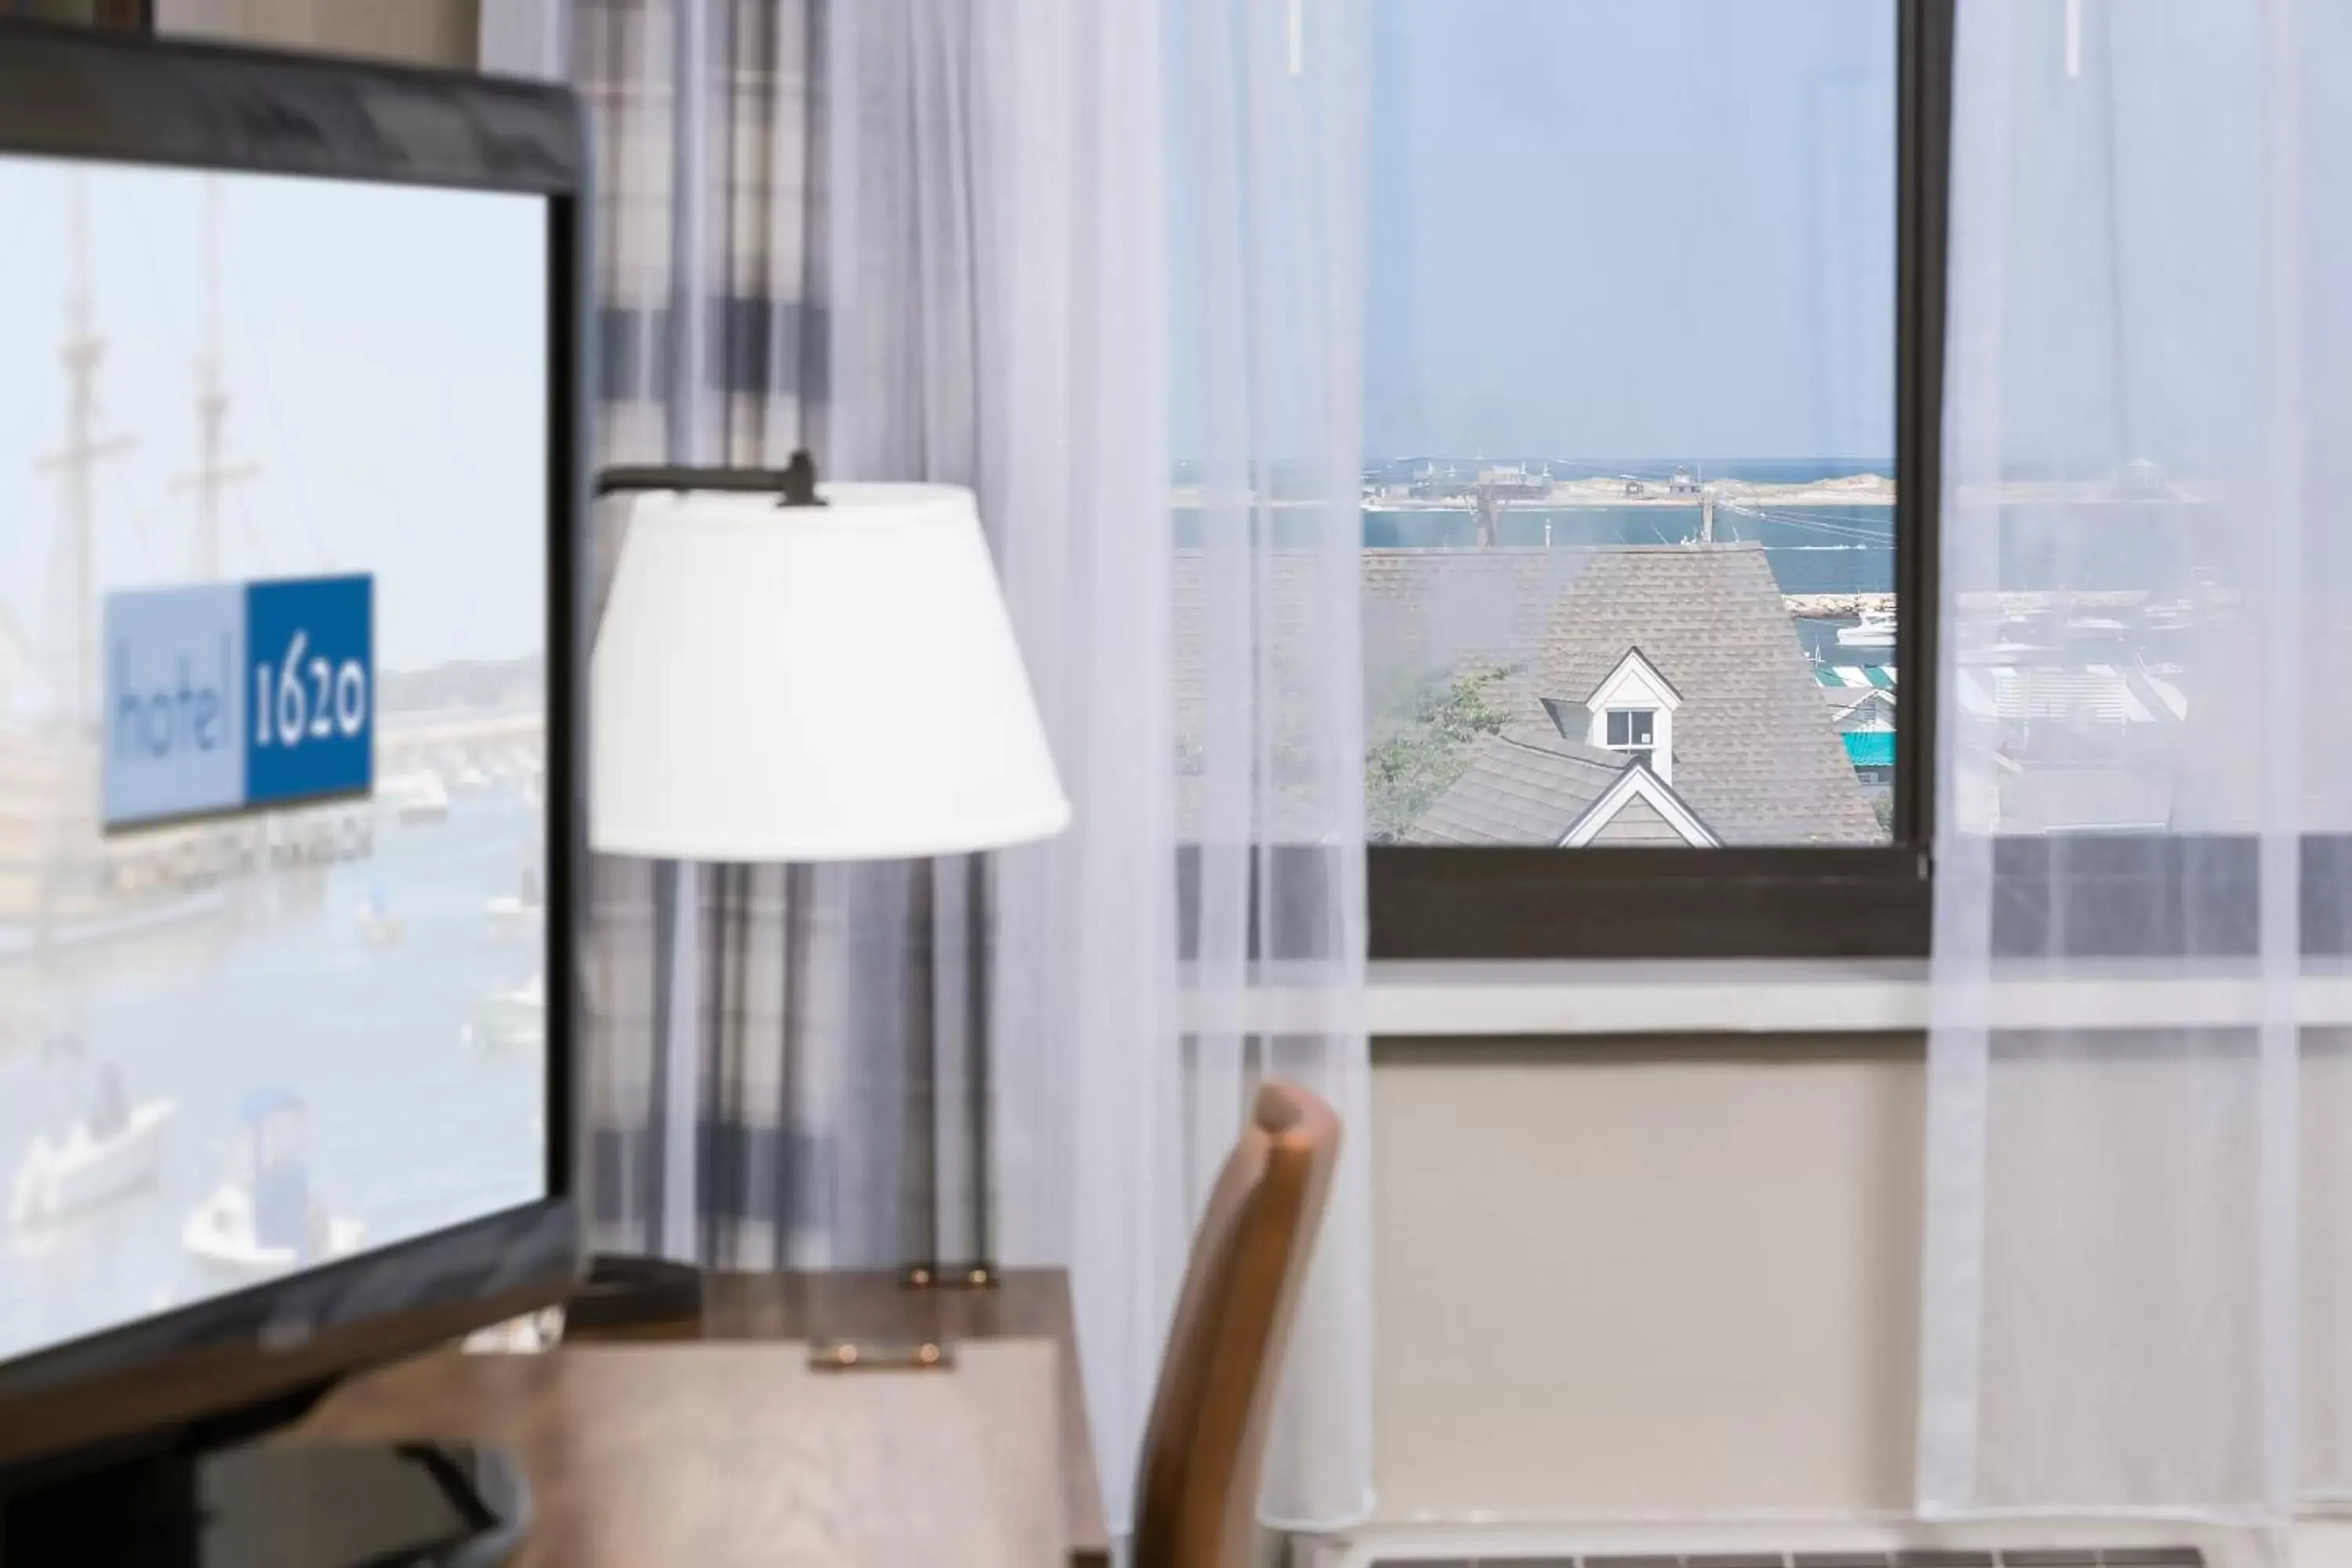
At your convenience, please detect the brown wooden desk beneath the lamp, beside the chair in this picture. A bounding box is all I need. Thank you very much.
[301,1269,1110,1568]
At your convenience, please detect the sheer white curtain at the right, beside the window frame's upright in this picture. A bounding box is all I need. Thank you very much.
[1919,0,2352,1523]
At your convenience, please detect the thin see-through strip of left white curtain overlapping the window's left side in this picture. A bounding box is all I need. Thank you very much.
[1164,0,1371,1528]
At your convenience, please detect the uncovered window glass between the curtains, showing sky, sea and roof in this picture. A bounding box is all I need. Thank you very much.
[1364,0,1903,844]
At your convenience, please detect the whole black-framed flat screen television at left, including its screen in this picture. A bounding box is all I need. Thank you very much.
[0,24,586,1523]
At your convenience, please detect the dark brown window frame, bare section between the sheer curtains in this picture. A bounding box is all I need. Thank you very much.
[1367,0,1955,959]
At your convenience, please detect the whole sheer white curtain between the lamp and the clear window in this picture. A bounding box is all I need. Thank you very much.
[828,0,1371,1523]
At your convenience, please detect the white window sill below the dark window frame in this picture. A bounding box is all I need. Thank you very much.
[1188,959,2352,1039]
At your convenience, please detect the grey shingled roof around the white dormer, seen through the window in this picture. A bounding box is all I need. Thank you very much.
[1174,543,1882,844]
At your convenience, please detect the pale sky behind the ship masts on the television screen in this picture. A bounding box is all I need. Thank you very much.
[0,158,548,700]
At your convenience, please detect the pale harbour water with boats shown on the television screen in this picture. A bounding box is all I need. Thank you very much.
[0,785,546,1359]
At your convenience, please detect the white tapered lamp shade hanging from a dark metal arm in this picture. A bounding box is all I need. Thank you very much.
[588,485,1070,860]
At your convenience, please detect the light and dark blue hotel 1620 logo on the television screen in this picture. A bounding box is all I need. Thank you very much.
[106,576,376,827]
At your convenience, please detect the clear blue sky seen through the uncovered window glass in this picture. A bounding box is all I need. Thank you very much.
[1364,0,1896,461]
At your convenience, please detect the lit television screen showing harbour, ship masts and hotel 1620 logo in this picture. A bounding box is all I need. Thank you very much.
[0,155,550,1361]
